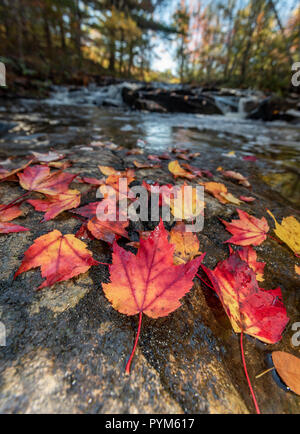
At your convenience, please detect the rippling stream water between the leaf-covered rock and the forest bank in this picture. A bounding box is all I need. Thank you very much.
[0,86,300,206]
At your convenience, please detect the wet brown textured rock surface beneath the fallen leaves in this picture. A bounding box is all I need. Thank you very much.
[0,141,300,413]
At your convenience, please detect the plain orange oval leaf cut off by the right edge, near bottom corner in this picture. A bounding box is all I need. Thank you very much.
[272,351,300,395]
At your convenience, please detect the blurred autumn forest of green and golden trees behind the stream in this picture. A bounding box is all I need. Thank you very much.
[0,0,300,93]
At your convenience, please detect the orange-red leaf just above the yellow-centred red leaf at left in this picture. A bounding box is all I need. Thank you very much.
[27,190,81,222]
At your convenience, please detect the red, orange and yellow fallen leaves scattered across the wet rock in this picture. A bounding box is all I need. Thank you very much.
[0,149,300,412]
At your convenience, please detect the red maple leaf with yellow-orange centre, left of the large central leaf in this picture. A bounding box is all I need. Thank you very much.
[14,230,98,289]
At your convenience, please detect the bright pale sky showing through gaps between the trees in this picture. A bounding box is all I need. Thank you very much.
[152,0,298,75]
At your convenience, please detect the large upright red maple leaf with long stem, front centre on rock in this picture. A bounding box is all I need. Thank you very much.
[103,221,202,373]
